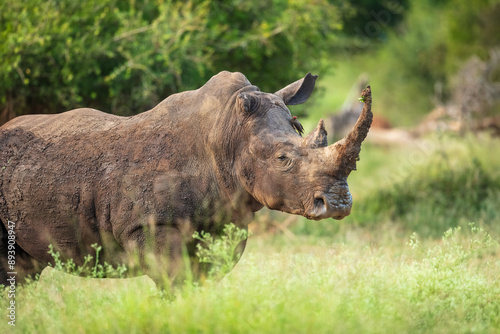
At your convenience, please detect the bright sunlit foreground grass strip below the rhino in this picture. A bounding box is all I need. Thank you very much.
[0,223,500,333]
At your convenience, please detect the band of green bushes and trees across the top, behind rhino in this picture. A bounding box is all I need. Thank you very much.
[0,0,500,125]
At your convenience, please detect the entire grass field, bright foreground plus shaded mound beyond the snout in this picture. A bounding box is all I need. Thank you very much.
[0,132,500,333]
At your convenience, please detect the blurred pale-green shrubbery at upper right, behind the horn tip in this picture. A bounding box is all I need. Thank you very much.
[320,0,500,127]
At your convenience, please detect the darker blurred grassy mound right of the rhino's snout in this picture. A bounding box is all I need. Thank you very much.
[348,132,500,237]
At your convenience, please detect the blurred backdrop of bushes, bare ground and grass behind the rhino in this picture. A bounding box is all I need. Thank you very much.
[0,0,500,239]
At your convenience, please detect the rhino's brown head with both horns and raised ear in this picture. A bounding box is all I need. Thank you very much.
[235,73,373,220]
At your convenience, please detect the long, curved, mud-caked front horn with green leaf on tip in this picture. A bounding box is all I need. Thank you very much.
[329,86,373,177]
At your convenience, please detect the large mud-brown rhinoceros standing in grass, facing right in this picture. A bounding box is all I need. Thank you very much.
[0,71,372,284]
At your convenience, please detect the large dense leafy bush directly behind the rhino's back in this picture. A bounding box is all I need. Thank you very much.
[0,0,341,115]
